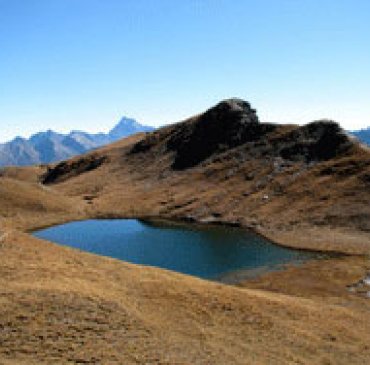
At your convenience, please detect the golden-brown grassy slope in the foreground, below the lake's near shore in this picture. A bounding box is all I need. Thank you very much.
[0,232,370,364]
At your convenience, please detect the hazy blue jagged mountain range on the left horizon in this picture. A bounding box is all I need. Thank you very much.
[0,117,154,166]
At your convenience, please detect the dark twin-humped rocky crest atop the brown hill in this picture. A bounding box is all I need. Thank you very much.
[131,99,354,170]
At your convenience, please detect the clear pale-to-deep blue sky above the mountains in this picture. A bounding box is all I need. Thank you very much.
[0,0,370,141]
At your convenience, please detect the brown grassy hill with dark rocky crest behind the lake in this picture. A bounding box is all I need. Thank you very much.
[44,99,370,253]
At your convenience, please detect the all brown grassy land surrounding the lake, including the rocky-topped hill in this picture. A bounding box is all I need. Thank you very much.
[0,100,370,364]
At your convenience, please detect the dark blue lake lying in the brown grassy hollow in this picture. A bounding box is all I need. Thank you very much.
[34,219,317,280]
